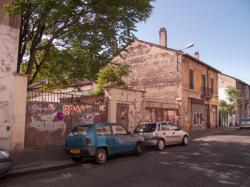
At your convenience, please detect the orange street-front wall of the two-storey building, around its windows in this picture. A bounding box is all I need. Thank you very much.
[182,57,218,130]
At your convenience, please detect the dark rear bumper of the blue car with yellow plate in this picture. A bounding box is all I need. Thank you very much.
[64,147,96,157]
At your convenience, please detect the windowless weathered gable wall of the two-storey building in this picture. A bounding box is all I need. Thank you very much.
[113,40,182,107]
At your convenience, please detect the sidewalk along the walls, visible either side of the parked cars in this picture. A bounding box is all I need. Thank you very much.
[7,127,236,177]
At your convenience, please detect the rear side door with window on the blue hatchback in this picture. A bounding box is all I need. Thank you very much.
[96,124,115,154]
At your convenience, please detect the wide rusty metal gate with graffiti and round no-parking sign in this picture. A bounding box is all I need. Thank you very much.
[25,92,108,146]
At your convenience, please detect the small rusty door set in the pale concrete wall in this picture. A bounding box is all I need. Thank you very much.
[116,103,129,128]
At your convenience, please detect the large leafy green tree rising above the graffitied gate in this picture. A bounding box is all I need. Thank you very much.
[6,0,152,86]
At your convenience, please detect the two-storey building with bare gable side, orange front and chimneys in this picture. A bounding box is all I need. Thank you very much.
[113,28,220,130]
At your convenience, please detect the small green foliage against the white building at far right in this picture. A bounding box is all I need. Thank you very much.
[219,87,240,115]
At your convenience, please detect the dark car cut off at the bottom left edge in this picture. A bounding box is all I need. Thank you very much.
[0,148,13,177]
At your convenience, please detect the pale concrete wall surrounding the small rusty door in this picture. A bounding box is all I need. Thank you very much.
[105,88,145,131]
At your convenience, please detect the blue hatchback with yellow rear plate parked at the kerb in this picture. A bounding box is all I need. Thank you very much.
[65,123,144,164]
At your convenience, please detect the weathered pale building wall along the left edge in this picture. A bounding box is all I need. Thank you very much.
[0,0,27,149]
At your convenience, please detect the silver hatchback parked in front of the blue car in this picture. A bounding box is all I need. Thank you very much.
[134,121,189,150]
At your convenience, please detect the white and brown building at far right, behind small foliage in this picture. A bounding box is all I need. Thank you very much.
[219,74,250,126]
